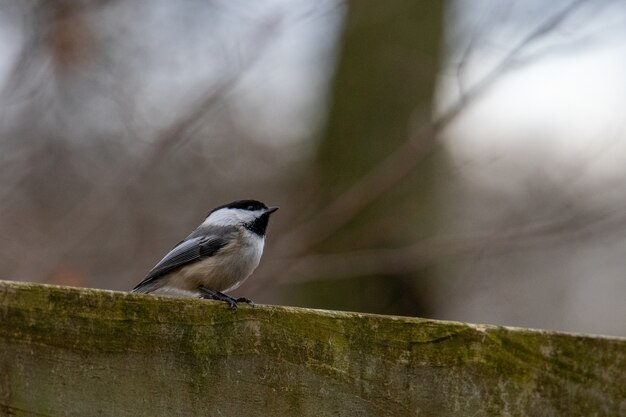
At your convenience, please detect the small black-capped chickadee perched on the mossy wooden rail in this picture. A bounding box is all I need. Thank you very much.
[133,200,278,308]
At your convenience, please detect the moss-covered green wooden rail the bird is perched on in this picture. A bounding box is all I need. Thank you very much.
[0,281,626,417]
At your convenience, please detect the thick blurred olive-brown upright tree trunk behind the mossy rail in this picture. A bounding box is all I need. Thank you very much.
[302,0,444,315]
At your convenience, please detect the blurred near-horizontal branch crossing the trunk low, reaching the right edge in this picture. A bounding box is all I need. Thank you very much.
[266,203,626,285]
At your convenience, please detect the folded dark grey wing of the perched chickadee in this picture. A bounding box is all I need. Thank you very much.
[133,235,228,292]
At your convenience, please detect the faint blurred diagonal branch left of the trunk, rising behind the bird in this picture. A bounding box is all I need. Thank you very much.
[8,11,281,278]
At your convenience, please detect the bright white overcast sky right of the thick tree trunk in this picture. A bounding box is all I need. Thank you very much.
[439,0,626,188]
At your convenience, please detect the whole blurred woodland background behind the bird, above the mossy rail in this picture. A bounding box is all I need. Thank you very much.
[0,0,626,336]
